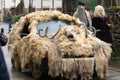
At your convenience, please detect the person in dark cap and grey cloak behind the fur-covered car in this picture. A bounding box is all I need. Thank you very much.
[73,1,92,27]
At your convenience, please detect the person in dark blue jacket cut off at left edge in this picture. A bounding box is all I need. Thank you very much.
[0,29,10,80]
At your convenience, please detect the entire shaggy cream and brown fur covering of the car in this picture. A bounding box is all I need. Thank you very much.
[8,11,112,80]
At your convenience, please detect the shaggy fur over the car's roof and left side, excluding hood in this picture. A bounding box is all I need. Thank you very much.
[8,11,76,69]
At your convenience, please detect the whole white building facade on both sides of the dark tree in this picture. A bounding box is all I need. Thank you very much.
[0,0,62,20]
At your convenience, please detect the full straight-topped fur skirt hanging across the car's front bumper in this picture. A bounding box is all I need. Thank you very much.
[61,58,94,80]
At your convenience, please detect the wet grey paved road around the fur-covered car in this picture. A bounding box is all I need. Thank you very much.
[0,23,120,80]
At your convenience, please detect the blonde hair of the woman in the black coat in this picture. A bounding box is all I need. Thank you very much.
[94,5,106,17]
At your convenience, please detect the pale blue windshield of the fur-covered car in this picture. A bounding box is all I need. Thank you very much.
[37,20,67,36]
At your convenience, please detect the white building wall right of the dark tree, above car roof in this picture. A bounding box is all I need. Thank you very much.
[24,0,62,11]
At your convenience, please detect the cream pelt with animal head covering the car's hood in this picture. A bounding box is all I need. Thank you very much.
[55,26,93,57]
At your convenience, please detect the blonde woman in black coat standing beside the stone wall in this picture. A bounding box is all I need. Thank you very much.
[92,5,112,44]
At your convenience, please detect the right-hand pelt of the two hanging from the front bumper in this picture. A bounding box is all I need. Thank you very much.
[78,57,94,80]
